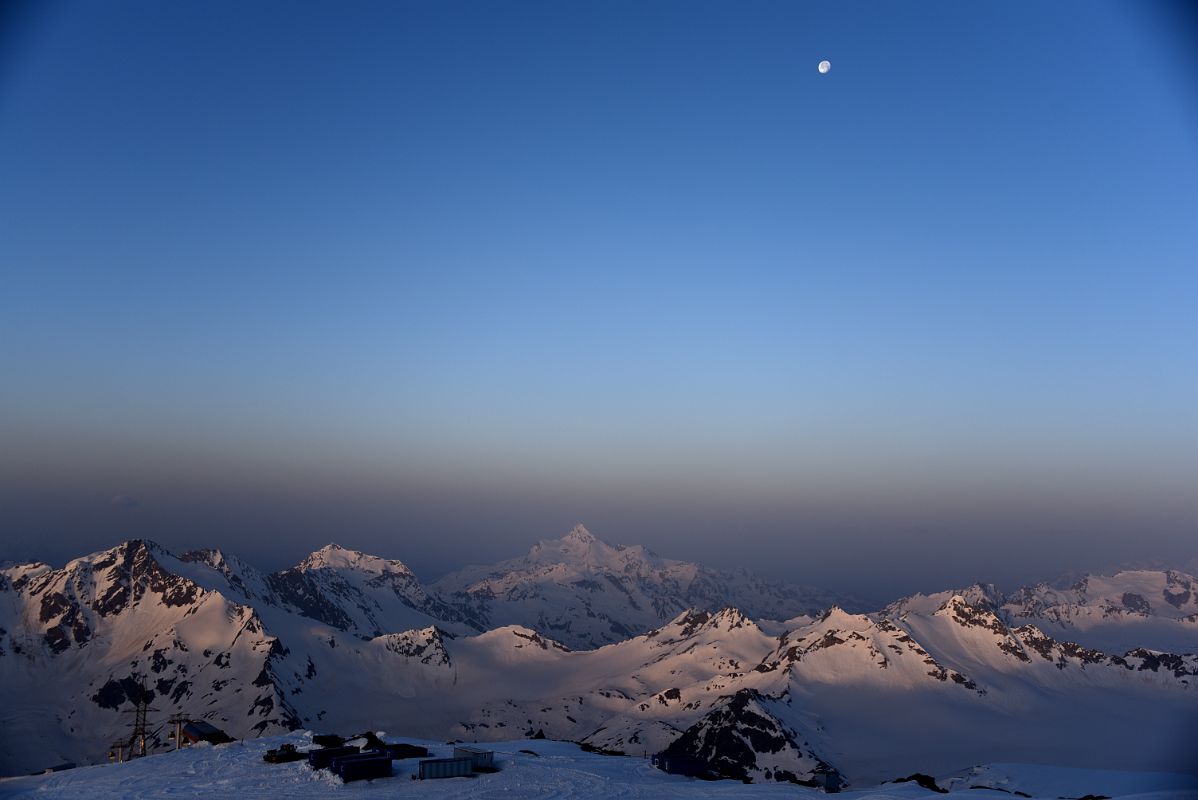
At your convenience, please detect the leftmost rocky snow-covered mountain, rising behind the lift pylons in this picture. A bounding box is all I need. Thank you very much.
[0,540,297,771]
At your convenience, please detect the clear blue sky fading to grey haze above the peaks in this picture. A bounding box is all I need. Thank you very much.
[0,0,1198,596]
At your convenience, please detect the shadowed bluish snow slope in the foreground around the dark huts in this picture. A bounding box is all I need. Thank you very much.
[0,733,1198,800]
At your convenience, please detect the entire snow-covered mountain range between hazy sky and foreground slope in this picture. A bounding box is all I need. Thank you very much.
[0,526,1198,784]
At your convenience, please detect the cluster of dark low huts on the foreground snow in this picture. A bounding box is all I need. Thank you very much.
[262,734,496,783]
